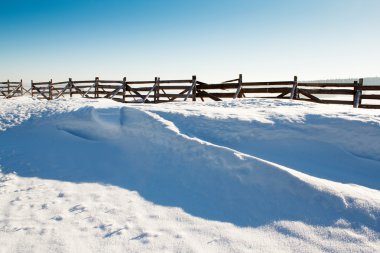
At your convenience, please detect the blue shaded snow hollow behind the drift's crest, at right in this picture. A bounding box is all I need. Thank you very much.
[151,111,380,190]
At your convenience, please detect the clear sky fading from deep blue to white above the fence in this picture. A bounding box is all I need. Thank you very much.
[0,0,380,83]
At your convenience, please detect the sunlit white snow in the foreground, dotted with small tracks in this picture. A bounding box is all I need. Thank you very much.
[0,174,380,253]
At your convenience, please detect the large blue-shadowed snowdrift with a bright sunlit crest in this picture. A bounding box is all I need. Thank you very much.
[0,107,380,232]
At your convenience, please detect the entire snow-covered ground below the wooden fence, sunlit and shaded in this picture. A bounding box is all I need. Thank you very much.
[0,97,380,252]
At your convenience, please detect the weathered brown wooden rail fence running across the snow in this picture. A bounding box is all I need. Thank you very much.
[2,74,380,109]
